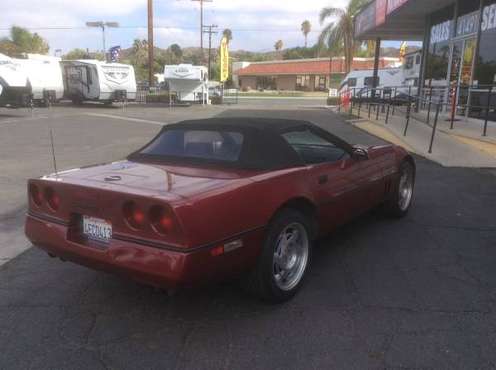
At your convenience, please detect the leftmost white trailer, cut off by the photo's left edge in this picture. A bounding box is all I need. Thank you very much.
[0,54,31,108]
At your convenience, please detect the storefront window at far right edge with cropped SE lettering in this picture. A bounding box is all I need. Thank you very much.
[474,0,496,85]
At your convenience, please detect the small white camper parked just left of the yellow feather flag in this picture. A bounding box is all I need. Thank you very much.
[164,64,208,104]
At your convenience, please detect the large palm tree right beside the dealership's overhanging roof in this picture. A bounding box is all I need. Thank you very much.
[319,0,369,73]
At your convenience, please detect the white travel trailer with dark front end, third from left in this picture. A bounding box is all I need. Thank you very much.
[61,60,136,104]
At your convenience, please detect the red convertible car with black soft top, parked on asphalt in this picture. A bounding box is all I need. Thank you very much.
[25,118,415,302]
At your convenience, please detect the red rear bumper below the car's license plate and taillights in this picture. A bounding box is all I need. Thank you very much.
[25,215,263,288]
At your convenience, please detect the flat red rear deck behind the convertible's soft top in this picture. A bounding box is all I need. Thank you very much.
[49,161,256,199]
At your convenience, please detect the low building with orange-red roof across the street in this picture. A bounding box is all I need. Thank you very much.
[233,57,399,91]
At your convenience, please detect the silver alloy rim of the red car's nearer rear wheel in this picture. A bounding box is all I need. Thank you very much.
[272,222,310,291]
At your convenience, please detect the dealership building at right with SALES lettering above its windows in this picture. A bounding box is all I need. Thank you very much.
[355,0,496,117]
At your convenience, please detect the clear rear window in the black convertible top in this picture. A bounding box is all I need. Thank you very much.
[140,129,244,162]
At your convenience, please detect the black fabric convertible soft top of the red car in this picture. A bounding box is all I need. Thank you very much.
[128,117,352,170]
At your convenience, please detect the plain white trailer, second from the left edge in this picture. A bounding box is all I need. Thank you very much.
[12,54,64,106]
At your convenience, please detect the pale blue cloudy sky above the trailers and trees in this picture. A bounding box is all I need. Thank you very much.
[0,0,402,54]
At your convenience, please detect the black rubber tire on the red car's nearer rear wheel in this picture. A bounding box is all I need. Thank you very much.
[245,208,312,303]
